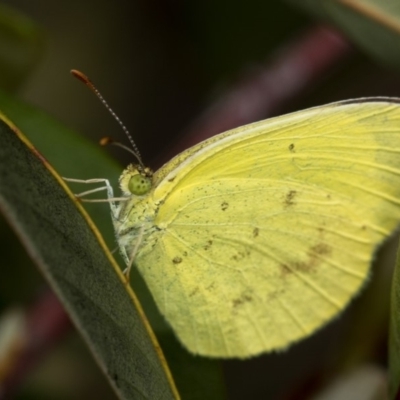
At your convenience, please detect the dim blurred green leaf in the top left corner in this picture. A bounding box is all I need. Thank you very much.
[0,4,44,91]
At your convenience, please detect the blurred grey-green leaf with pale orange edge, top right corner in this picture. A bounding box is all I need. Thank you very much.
[288,0,400,68]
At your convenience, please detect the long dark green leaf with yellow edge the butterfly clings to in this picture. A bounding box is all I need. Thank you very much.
[0,114,178,399]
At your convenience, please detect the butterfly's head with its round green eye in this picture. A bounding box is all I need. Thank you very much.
[119,164,153,196]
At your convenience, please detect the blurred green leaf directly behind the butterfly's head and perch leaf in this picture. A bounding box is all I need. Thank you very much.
[0,91,225,399]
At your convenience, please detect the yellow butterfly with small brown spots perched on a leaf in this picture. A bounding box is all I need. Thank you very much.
[67,71,400,358]
